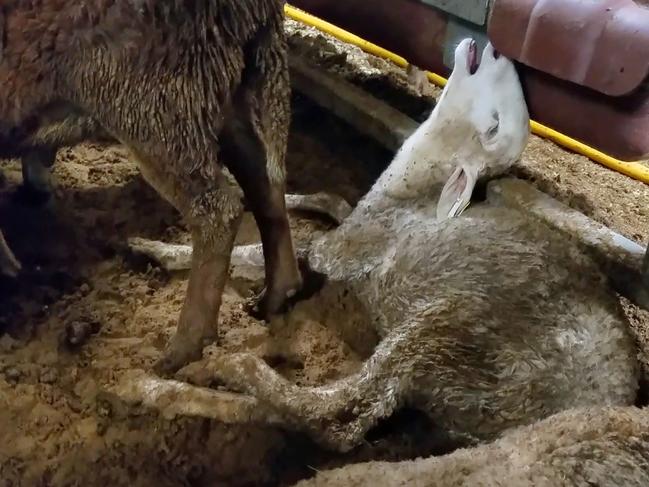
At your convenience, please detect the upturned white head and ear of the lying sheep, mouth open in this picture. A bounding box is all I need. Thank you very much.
[431,39,530,220]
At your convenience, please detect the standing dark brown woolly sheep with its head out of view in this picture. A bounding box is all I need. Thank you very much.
[0,0,302,372]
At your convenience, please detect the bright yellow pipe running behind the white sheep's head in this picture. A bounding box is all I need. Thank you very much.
[284,4,649,184]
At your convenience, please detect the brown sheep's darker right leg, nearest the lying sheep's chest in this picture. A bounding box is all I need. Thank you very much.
[219,28,302,319]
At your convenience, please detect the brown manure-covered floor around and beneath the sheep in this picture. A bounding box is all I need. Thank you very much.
[0,22,649,486]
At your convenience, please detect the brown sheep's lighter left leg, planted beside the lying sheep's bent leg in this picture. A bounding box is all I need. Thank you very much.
[128,151,243,374]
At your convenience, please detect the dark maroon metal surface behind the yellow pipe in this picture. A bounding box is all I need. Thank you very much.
[291,0,649,161]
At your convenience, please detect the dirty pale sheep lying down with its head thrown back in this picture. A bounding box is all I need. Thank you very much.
[128,40,638,451]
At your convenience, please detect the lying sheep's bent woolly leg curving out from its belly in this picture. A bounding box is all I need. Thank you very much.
[177,325,420,452]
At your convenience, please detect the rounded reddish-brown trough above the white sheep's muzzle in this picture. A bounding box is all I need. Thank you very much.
[488,0,649,96]
